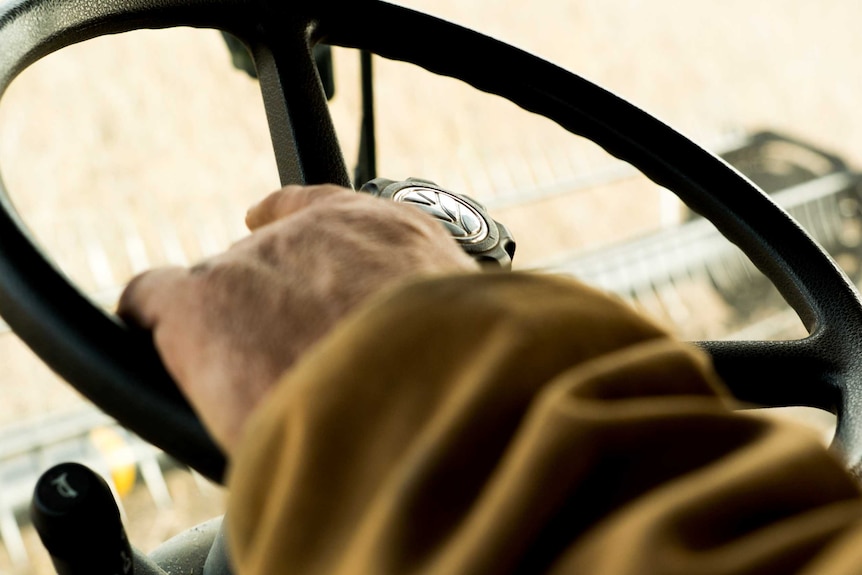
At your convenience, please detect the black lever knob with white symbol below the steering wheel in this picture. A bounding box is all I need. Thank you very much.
[30,463,133,575]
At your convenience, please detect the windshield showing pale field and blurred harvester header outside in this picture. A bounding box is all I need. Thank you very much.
[0,0,862,573]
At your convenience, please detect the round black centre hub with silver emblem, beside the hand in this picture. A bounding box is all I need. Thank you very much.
[359,178,515,270]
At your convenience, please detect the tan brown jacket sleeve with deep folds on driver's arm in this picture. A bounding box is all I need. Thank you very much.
[228,274,862,575]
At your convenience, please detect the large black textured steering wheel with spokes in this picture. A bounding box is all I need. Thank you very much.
[0,0,862,481]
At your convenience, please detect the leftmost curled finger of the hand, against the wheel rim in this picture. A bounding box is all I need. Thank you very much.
[117,267,189,330]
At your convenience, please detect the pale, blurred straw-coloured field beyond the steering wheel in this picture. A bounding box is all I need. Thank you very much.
[0,0,862,572]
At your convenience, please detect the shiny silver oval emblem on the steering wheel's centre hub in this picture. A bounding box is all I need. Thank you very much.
[392,186,488,244]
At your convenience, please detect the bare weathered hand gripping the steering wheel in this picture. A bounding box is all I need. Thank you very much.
[118,185,478,455]
